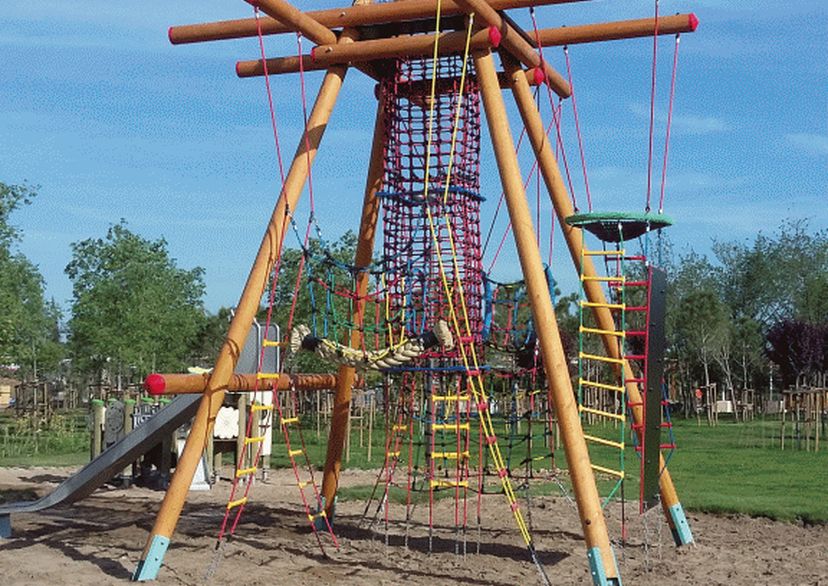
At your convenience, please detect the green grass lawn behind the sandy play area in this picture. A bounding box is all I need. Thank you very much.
[0,410,828,523]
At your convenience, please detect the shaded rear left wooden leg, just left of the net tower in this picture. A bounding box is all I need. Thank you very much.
[322,90,385,520]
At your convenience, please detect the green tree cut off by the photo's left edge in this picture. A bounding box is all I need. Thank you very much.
[0,183,62,376]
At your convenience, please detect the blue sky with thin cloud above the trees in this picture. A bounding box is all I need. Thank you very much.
[0,0,828,310]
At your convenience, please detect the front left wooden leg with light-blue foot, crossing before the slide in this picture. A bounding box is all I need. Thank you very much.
[133,61,347,581]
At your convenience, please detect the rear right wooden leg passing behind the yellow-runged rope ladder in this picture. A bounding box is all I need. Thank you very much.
[503,55,693,545]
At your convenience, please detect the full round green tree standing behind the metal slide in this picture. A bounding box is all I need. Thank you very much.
[66,220,204,381]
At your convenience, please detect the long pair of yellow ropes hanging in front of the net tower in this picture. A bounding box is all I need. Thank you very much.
[423,11,532,546]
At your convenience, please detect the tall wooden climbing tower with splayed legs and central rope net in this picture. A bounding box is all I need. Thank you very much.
[134,0,697,586]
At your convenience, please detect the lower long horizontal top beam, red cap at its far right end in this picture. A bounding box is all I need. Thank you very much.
[236,14,698,78]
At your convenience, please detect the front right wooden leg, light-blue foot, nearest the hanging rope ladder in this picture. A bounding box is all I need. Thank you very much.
[474,51,621,586]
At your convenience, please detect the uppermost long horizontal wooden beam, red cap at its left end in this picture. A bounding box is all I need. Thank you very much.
[168,0,583,45]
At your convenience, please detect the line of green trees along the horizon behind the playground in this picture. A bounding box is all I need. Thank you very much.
[0,183,828,408]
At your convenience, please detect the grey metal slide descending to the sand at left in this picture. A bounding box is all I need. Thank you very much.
[0,393,202,538]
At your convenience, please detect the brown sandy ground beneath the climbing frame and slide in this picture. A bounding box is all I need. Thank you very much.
[0,468,828,586]
